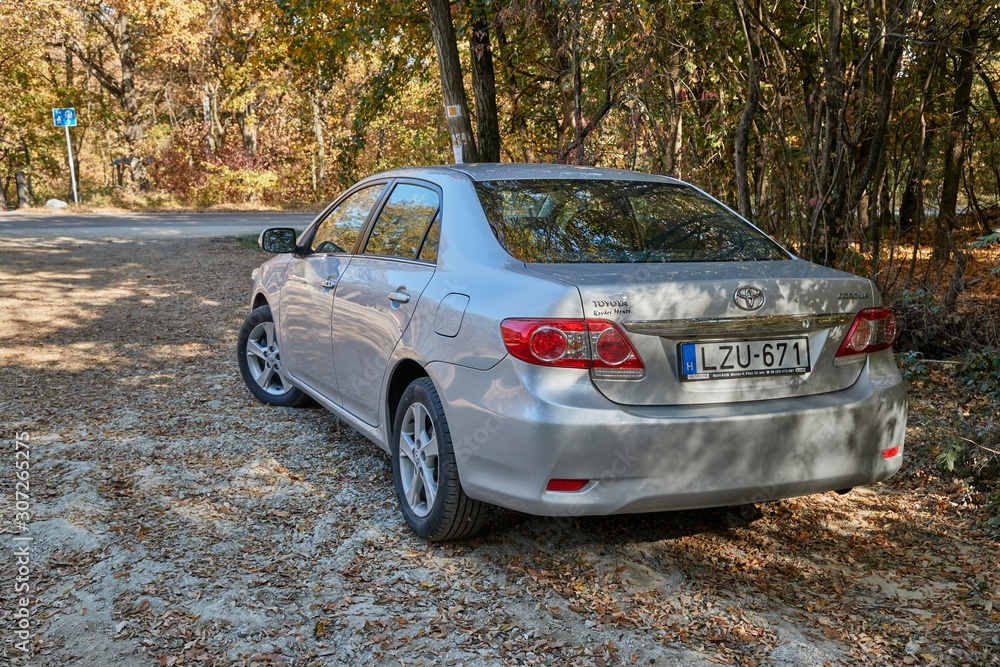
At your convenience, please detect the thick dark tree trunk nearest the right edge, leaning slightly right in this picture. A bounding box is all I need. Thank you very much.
[934,23,979,260]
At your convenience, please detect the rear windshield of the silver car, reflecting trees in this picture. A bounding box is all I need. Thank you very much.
[476,179,788,264]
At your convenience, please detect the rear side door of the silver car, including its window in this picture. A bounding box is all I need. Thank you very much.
[333,181,441,426]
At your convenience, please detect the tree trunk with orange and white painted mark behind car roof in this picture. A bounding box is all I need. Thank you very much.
[427,0,479,162]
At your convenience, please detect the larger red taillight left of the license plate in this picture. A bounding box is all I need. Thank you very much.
[500,319,646,380]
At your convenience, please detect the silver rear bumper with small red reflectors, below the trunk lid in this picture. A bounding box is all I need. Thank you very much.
[428,351,906,516]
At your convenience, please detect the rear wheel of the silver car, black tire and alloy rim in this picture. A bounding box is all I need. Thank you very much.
[391,378,489,542]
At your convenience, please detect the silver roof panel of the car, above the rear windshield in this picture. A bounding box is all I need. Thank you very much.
[368,162,682,184]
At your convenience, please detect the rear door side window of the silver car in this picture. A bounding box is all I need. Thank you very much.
[365,183,440,261]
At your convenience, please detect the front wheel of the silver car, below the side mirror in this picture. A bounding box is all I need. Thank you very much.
[236,304,310,408]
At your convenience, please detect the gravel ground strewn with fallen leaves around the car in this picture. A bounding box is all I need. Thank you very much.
[0,239,1000,666]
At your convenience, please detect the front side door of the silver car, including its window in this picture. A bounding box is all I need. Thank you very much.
[278,183,386,403]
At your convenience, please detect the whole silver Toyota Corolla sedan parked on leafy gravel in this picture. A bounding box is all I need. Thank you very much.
[238,164,906,540]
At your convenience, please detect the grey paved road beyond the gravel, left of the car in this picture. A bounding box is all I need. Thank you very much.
[0,211,316,241]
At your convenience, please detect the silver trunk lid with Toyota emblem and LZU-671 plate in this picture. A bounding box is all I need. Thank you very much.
[527,259,874,405]
